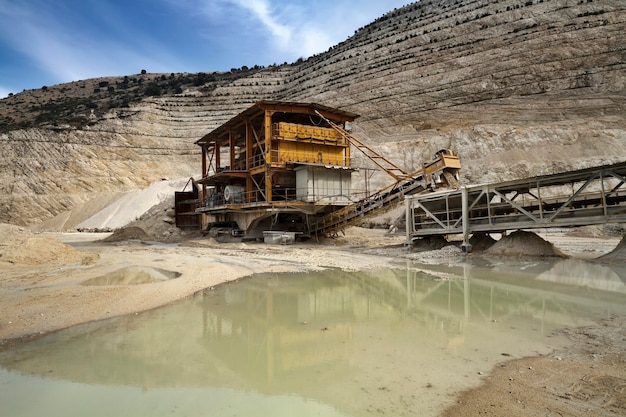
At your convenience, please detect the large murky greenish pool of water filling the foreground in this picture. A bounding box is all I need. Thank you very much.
[0,259,626,416]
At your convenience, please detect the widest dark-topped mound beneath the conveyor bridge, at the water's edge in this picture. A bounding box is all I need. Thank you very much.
[485,230,565,257]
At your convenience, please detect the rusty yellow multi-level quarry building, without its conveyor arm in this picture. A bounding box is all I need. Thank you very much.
[190,101,358,237]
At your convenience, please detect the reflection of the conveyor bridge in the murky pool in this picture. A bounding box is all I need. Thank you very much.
[406,259,626,331]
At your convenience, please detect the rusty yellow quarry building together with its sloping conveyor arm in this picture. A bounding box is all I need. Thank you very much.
[184,101,460,239]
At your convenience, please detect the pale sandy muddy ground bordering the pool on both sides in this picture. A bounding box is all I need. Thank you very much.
[0,225,626,416]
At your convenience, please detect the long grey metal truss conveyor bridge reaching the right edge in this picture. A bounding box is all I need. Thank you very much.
[406,162,626,250]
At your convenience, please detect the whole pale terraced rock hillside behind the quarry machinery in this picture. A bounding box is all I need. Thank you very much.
[0,0,626,224]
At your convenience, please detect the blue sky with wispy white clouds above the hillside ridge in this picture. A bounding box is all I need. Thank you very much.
[0,0,411,97]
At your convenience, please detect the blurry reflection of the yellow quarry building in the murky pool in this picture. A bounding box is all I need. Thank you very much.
[202,277,354,382]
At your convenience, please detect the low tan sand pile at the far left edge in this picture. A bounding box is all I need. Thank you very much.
[0,224,98,265]
